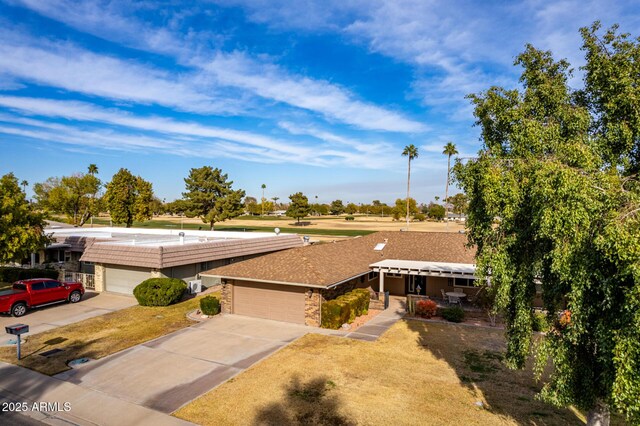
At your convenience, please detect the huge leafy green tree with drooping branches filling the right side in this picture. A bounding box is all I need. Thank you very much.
[455,23,640,424]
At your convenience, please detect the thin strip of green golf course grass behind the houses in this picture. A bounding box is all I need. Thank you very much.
[85,218,376,237]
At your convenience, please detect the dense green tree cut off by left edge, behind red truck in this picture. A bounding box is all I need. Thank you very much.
[0,173,48,263]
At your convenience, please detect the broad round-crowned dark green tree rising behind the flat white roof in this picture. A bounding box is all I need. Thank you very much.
[182,166,245,231]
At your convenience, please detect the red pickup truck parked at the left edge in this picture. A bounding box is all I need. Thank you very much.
[0,278,84,317]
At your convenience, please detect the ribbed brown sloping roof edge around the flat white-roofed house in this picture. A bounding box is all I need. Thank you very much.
[80,235,302,269]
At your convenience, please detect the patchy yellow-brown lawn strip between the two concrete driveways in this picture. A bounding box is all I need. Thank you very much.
[0,293,219,375]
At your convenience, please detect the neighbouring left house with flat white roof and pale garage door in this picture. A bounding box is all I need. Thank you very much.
[45,227,303,294]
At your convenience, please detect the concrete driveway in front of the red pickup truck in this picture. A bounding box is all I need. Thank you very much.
[0,291,138,342]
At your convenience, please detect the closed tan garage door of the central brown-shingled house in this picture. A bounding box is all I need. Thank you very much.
[233,282,305,324]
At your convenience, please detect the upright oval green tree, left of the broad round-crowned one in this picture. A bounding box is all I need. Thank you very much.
[104,168,153,228]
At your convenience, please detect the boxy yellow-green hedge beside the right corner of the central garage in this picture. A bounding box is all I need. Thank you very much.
[321,288,371,330]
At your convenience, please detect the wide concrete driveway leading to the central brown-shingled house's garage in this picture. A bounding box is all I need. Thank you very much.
[55,315,316,413]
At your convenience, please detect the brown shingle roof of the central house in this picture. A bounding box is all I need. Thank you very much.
[201,231,475,286]
